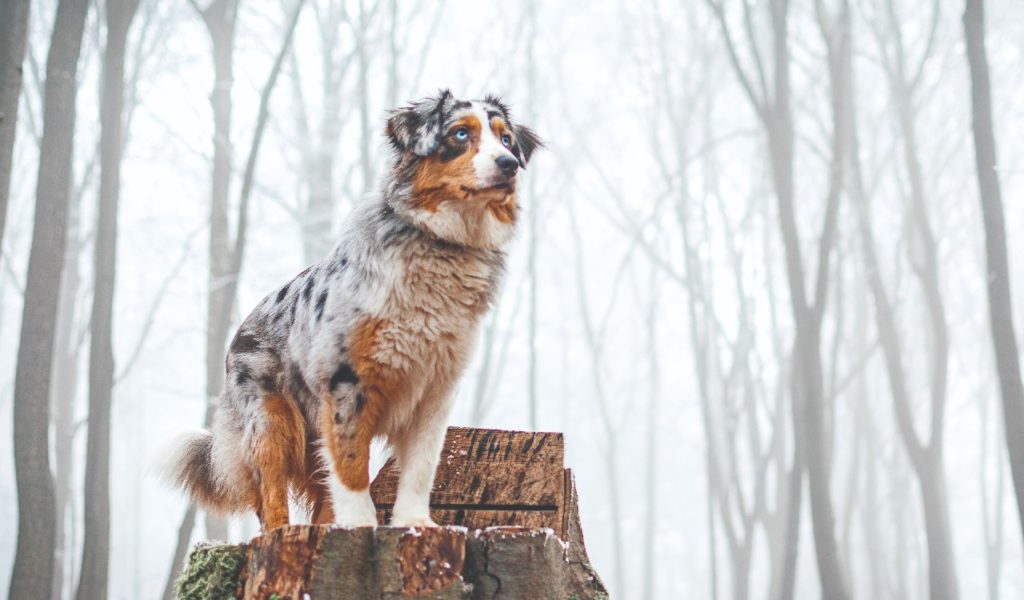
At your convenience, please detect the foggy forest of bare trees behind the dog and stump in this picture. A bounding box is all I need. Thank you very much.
[0,0,1024,600]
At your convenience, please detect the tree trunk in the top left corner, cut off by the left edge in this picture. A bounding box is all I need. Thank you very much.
[0,0,29,248]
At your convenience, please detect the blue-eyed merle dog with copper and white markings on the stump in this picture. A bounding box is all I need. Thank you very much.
[167,90,543,531]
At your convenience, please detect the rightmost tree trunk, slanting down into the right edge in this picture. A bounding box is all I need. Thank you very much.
[964,0,1024,544]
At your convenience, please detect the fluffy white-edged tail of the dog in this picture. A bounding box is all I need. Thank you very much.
[162,429,252,513]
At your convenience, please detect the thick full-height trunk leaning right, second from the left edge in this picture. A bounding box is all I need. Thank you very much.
[9,0,88,598]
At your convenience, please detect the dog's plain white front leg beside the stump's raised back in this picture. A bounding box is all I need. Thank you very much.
[391,394,451,527]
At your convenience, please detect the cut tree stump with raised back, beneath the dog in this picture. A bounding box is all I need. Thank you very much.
[178,427,607,600]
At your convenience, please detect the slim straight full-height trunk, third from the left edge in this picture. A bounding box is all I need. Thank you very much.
[78,0,138,600]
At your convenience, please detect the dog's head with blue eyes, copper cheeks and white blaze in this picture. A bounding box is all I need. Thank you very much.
[385,90,542,248]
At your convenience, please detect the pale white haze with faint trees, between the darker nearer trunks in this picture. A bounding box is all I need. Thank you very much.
[0,0,1024,598]
